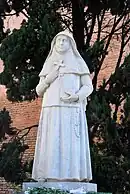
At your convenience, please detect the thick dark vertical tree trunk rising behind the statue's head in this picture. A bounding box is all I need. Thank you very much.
[71,0,84,52]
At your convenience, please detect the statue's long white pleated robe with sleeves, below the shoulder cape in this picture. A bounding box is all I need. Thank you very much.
[32,72,93,181]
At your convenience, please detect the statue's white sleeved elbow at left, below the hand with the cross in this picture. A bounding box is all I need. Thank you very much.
[36,76,49,97]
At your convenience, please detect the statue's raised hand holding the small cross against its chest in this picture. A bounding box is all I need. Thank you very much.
[45,66,59,84]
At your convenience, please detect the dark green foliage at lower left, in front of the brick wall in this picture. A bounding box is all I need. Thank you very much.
[0,108,37,184]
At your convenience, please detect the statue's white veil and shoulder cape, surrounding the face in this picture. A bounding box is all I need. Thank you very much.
[39,30,90,77]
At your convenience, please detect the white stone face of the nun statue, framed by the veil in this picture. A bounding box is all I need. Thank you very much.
[55,35,70,53]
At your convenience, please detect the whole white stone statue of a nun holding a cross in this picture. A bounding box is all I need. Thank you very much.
[32,31,93,181]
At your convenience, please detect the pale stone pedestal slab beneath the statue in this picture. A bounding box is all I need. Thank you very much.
[23,182,97,193]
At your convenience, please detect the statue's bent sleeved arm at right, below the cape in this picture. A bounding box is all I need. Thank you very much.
[77,75,93,101]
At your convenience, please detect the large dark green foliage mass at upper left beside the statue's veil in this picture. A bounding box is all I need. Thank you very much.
[0,1,61,101]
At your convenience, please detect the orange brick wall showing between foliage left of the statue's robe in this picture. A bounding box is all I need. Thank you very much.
[0,98,41,194]
